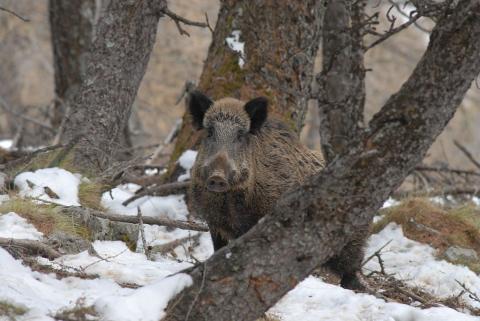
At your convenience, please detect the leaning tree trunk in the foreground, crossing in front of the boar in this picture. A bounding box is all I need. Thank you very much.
[164,0,480,321]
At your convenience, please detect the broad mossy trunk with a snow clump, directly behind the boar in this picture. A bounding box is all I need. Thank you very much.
[167,0,324,179]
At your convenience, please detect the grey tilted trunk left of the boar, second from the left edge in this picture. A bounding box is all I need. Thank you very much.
[62,0,166,173]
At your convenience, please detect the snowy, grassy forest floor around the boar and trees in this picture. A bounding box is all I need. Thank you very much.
[0,143,480,321]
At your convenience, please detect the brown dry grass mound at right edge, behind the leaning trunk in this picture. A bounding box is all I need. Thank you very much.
[373,198,480,273]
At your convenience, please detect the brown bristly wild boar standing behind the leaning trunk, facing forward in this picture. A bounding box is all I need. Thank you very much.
[189,91,367,288]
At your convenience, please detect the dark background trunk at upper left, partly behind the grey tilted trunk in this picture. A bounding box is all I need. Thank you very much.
[48,0,97,128]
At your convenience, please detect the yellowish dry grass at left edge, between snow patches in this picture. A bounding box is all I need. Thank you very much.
[0,197,89,238]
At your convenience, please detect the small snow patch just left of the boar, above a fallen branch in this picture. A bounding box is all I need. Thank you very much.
[101,184,188,220]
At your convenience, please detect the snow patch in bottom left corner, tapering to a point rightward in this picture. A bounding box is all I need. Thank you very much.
[0,248,134,320]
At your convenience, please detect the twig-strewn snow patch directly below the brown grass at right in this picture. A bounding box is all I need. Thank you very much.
[364,223,480,308]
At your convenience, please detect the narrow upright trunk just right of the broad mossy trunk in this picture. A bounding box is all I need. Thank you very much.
[316,0,365,163]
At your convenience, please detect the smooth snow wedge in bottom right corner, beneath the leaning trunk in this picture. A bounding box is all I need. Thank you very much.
[268,276,478,321]
